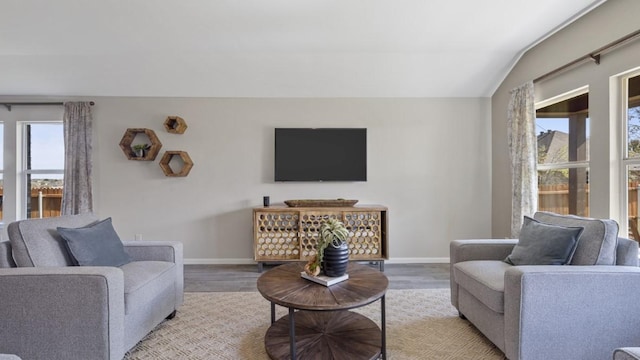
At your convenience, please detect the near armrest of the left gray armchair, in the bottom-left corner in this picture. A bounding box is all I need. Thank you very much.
[0,266,124,359]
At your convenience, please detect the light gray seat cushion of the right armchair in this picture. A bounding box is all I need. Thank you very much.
[453,260,512,314]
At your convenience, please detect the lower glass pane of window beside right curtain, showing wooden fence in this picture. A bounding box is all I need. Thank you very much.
[538,168,589,216]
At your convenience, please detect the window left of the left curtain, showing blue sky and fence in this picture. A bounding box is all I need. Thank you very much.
[21,122,64,218]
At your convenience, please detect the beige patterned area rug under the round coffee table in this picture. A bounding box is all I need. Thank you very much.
[125,289,504,360]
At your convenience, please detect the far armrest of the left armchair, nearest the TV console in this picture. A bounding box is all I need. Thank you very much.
[122,240,184,309]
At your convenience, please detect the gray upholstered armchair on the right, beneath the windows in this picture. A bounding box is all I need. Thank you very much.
[450,212,640,360]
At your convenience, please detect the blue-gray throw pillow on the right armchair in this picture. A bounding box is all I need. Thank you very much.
[504,216,584,265]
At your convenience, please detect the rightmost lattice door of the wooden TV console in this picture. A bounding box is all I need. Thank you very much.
[342,211,383,260]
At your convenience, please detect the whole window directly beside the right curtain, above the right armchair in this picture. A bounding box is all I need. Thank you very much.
[536,88,589,216]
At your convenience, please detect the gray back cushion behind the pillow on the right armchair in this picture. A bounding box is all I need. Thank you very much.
[533,211,618,265]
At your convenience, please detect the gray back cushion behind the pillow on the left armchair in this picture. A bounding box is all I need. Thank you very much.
[7,214,98,267]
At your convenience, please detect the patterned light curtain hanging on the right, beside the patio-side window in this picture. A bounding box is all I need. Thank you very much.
[507,81,538,238]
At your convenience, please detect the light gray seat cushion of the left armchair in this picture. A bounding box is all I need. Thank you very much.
[120,261,177,315]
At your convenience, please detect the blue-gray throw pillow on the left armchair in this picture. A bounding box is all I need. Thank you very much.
[57,218,131,266]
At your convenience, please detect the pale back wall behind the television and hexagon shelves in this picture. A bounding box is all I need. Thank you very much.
[0,97,491,263]
